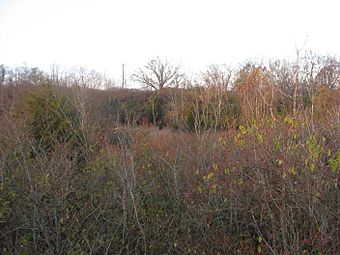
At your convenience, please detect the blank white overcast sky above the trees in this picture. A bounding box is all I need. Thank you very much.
[0,0,340,83]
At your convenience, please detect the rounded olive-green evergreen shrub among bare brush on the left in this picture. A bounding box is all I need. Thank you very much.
[20,84,80,152]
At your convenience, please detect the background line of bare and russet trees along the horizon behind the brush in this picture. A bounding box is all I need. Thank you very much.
[0,52,340,132]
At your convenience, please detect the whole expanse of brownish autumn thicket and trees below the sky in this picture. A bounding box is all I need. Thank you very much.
[0,54,340,254]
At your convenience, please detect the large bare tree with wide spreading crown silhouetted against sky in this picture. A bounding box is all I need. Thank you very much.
[132,57,183,90]
